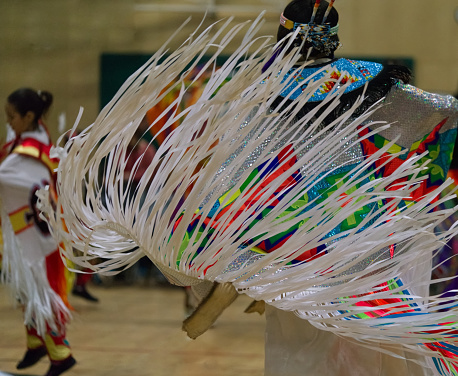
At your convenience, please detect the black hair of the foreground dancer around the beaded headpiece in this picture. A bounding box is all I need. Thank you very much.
[277,0,339,56]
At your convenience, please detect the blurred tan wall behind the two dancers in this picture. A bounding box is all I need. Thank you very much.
[0,0,458,141]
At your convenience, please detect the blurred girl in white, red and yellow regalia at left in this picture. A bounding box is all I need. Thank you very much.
[0,88,75,376]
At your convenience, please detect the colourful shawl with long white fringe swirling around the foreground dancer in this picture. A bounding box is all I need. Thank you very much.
[39,21,458,369]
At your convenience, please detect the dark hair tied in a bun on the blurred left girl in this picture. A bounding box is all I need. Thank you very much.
[7,88,53,122]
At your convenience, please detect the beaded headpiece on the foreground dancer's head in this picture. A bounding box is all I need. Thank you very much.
[280,0,340,55]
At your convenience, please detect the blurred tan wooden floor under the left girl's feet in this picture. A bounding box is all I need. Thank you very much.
[0,285,264,376]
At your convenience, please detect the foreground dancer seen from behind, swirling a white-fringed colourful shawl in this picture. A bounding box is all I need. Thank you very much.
[44,0,458,376]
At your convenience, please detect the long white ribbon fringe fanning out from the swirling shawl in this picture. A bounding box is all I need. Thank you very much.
[38,18,458,368]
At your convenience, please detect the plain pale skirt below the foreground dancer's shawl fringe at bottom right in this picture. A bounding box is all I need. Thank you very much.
[265,305,434,376]
